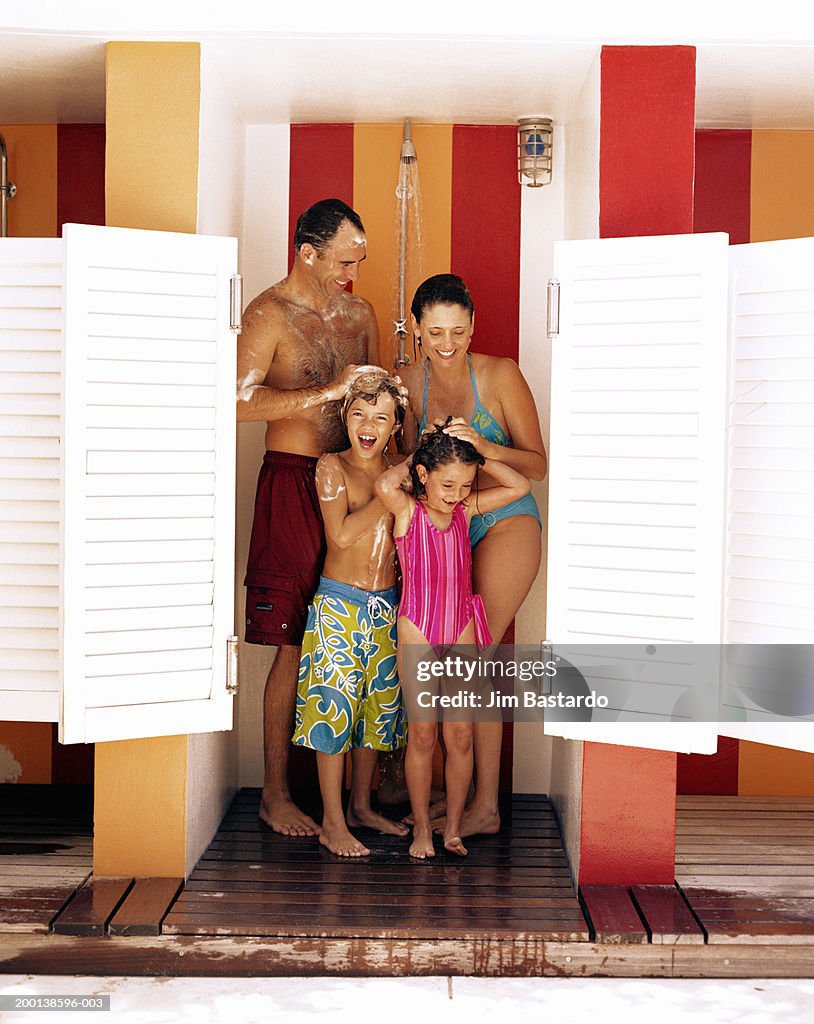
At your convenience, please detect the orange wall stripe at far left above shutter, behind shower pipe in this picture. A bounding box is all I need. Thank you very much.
[0,125,56,239]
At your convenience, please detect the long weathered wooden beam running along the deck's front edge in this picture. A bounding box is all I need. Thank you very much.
[7,935,814,979]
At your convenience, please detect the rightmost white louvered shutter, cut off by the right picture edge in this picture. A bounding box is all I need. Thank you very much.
[721,239,814,751]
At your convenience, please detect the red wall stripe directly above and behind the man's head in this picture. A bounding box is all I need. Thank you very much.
[289,124,353,266]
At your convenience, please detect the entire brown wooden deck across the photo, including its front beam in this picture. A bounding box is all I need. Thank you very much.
[0,791,814,978]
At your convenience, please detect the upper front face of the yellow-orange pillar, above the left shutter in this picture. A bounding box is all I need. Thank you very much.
[105,42,201,232]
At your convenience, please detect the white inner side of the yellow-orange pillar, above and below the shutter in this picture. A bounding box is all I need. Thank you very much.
[186,45,245,872]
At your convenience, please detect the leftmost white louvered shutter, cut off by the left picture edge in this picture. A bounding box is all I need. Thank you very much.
[0,239,62,722]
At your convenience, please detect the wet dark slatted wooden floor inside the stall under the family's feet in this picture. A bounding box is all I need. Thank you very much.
[162,790,590,941]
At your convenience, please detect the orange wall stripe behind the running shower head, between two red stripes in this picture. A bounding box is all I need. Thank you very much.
[353,124,453,369]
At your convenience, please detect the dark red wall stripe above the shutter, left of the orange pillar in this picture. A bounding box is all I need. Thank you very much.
[56,124,104,236]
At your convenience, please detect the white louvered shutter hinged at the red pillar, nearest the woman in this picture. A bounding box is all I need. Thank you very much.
[546,234,728,753]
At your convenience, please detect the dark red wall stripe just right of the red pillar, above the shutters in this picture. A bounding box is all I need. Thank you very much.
[693,129,752,245]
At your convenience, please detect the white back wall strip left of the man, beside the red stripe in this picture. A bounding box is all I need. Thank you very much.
[234,124,291,786]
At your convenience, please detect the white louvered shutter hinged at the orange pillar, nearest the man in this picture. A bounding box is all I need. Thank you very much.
[60,225,237,742]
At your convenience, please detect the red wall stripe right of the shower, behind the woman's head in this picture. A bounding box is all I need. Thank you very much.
[451,125,520,359]
